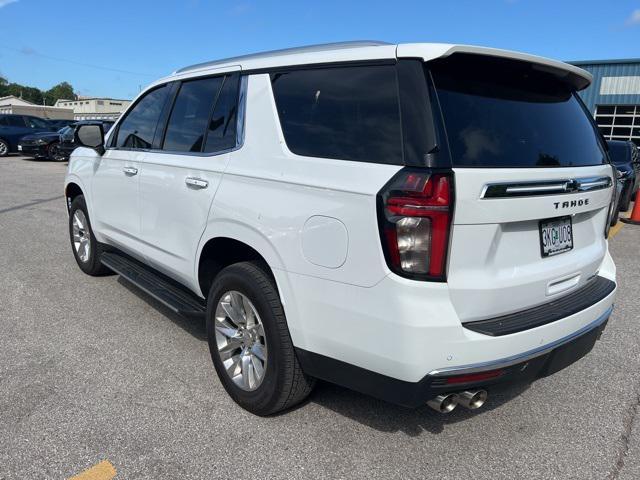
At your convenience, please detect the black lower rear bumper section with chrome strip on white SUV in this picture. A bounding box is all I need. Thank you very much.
[296,307,612,408]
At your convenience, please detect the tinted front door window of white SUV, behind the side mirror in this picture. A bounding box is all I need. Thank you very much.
[116,86,168,148]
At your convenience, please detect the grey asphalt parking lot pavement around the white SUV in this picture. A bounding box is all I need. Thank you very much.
[0,156,640,480]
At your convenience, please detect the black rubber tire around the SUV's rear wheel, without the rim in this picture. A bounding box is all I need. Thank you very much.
[207,262,315,416]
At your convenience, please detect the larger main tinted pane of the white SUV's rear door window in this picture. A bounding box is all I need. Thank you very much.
[163,77,224,152]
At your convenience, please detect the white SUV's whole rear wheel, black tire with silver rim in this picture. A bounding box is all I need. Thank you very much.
[207,262,315,416]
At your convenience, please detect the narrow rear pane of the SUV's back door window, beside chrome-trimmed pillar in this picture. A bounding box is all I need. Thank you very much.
[204,74,240,152]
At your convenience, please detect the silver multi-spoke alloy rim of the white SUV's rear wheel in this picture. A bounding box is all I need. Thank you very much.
[214,291,268,391]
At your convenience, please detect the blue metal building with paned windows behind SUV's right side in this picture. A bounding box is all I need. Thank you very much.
[569,58,640,146]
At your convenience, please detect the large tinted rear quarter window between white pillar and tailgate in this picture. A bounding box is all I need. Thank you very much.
[271,65,402,164]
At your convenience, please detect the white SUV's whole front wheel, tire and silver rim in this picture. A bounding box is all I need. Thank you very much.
[69,195,111,277]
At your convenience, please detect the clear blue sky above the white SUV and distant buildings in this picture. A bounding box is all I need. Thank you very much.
[0,0,640,98]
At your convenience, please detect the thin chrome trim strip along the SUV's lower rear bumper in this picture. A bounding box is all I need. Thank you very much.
[427,306,615,377]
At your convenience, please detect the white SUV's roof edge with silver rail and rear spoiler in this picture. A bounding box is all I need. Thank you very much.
[164,41,592,90]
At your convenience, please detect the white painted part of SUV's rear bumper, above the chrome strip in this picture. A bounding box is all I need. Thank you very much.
[274,253,615,382]
